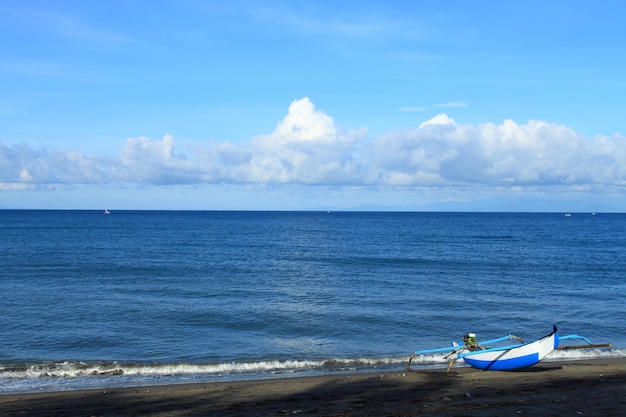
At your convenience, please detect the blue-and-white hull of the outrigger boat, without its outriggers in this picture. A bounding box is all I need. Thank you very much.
[459,332,559,371]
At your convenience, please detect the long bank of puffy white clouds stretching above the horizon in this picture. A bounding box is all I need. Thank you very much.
[0,98,626,195]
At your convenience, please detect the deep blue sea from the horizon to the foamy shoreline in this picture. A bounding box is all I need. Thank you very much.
[0,210,626,393]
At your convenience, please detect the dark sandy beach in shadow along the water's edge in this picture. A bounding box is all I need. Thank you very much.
[0,358,626,417]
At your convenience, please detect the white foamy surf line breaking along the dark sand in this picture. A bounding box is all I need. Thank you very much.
[0,349,626,392]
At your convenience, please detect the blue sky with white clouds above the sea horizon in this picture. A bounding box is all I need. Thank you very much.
[0,0,626,208]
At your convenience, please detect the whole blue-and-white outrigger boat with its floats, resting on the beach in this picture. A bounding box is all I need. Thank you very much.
[406,326,611,372]
